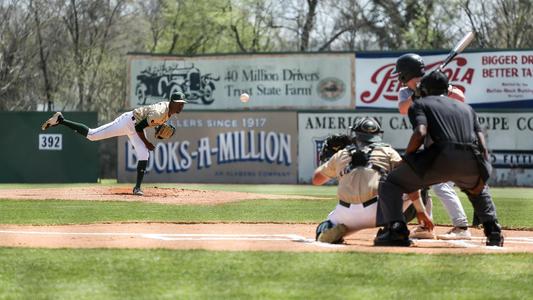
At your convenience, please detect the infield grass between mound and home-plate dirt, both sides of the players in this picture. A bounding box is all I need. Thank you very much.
[0,185,533,229]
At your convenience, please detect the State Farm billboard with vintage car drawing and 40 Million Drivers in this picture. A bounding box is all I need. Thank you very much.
[128,53,355,110]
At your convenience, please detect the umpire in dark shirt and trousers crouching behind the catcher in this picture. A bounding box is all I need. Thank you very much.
[374,71,503,246]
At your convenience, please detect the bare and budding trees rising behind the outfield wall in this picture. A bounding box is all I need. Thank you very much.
[0,0,533,122]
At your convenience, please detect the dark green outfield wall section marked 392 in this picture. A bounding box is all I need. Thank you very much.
[0,112,99,183]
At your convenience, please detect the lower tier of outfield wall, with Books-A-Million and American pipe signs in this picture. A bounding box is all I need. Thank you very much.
[117,111,533,186]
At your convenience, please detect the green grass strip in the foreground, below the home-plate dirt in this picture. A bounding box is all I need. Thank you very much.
[0,248,533,299]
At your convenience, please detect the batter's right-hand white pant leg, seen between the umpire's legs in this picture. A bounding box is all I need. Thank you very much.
[431,181,468,227]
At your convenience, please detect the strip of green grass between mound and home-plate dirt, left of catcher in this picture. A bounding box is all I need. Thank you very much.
[0,200,330,225]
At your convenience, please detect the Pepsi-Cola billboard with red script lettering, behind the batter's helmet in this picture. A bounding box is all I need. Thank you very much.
[355,50,533,108]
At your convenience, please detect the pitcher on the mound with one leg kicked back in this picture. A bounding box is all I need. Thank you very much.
[41,93,187,196]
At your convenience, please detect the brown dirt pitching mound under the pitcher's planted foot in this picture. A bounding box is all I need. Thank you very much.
[1,186,321,204]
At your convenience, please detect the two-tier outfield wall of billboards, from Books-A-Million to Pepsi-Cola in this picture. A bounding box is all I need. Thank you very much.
[117,49,533,186]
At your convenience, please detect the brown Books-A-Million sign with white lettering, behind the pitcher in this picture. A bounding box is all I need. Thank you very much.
[118,112,297,183]
